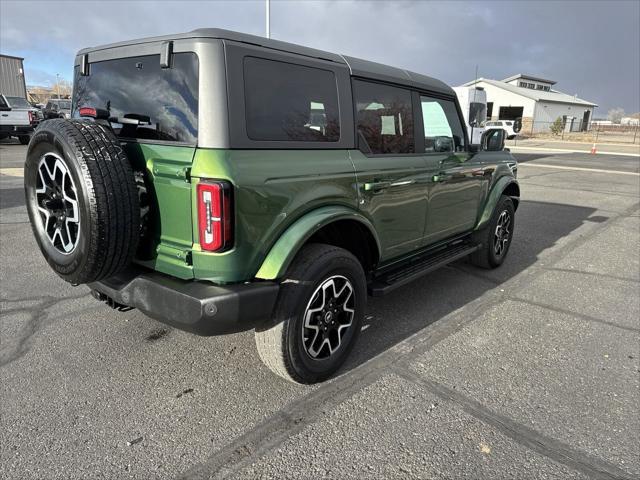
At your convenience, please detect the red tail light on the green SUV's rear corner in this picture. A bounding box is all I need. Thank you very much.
[196,180,233,252]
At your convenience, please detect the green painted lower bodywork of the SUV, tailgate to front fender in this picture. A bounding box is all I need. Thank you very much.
[126,143,515,284]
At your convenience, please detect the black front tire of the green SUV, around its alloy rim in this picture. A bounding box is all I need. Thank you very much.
[470,195,515,269]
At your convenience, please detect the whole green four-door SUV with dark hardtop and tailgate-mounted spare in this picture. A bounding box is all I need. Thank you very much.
[24,29,520,383]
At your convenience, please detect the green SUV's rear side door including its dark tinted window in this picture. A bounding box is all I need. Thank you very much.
[351,80,428,262]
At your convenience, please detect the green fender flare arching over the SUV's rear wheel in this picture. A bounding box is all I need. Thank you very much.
[256,207,379,280]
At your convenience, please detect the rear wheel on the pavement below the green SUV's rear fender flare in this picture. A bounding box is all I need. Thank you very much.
[255,244,366,383]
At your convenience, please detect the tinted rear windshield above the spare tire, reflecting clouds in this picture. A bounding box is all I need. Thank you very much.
[72,52,198,144]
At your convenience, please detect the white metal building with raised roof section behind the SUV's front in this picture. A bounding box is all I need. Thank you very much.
[464,74,598,134]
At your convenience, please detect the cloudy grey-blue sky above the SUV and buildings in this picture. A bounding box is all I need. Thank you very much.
[0,0,640,117]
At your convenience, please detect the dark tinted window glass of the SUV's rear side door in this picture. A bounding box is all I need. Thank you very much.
[353,80,415,154]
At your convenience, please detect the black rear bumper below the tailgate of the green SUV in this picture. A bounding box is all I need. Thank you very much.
[88,270,279,335]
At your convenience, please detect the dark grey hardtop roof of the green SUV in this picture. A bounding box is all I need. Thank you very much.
[78,28,454,95]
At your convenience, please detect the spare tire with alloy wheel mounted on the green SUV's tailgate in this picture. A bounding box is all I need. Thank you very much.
[24,119,140,284]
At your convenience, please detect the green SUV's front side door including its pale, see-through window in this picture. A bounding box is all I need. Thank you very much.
[420,95,490,245]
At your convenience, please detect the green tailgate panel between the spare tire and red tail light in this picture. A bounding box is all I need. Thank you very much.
[125,143,196,279]
